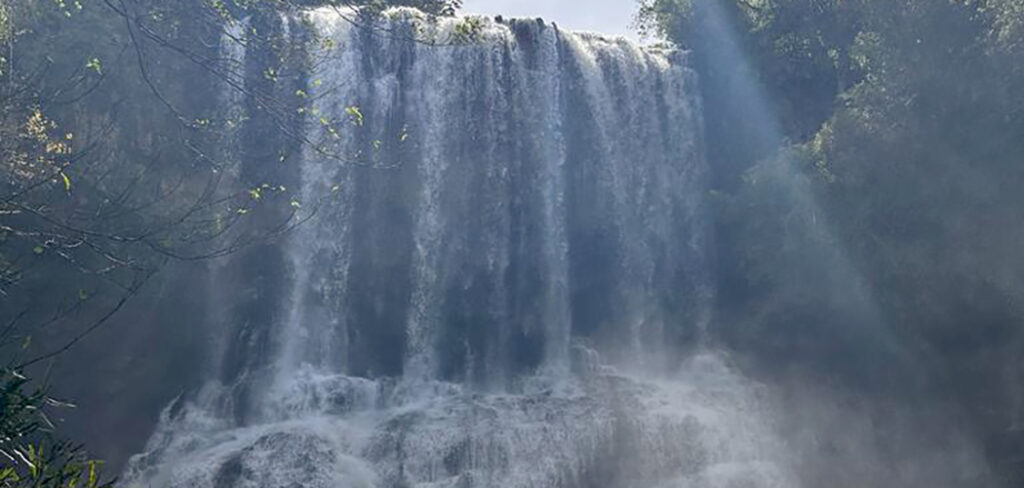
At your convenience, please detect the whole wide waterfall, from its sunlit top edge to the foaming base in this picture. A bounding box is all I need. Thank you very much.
[117,8,799,488]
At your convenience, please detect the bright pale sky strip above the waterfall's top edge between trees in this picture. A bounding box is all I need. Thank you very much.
[462,0,637,40]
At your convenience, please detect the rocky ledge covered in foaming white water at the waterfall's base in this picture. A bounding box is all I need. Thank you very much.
[121,354,799,488]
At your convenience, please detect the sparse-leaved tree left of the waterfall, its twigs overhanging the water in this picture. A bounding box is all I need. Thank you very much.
[0,0,468,478]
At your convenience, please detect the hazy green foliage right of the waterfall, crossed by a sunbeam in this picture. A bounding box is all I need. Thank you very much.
[641,0,1024,478]
